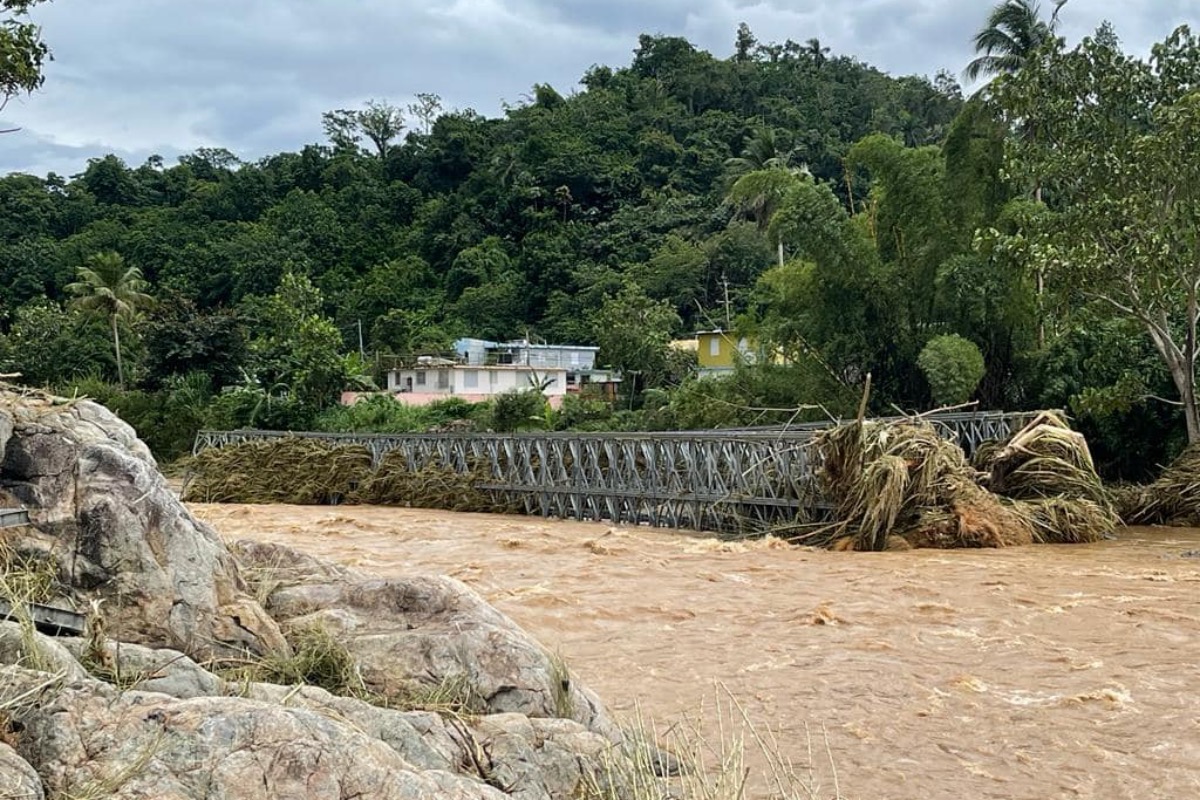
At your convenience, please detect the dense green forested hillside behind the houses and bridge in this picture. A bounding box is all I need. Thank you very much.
[0,15,1177,474]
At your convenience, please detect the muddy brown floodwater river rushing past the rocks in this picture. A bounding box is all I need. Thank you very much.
[192,505,1200,800]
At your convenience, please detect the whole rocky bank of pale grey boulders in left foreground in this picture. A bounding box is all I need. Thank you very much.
[0,389,666,800]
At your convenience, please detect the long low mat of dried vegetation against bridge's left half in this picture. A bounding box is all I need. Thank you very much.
[184,437,511,511]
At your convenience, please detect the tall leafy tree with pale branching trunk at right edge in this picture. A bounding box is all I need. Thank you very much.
[998,26,1200,441]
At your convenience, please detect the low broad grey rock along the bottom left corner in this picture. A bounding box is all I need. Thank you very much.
[0,667,505,800]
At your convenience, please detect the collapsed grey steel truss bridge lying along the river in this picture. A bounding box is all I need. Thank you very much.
[193,411,1033,534]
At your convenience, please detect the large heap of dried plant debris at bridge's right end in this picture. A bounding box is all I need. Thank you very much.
[797,414,1117,551]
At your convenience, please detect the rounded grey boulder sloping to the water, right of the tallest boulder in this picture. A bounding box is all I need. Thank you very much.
[233,541,622,741]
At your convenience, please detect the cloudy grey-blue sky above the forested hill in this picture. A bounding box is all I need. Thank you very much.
[0,0,1200,175]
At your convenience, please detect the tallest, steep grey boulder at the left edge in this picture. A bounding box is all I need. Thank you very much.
[0,390,287,658]
